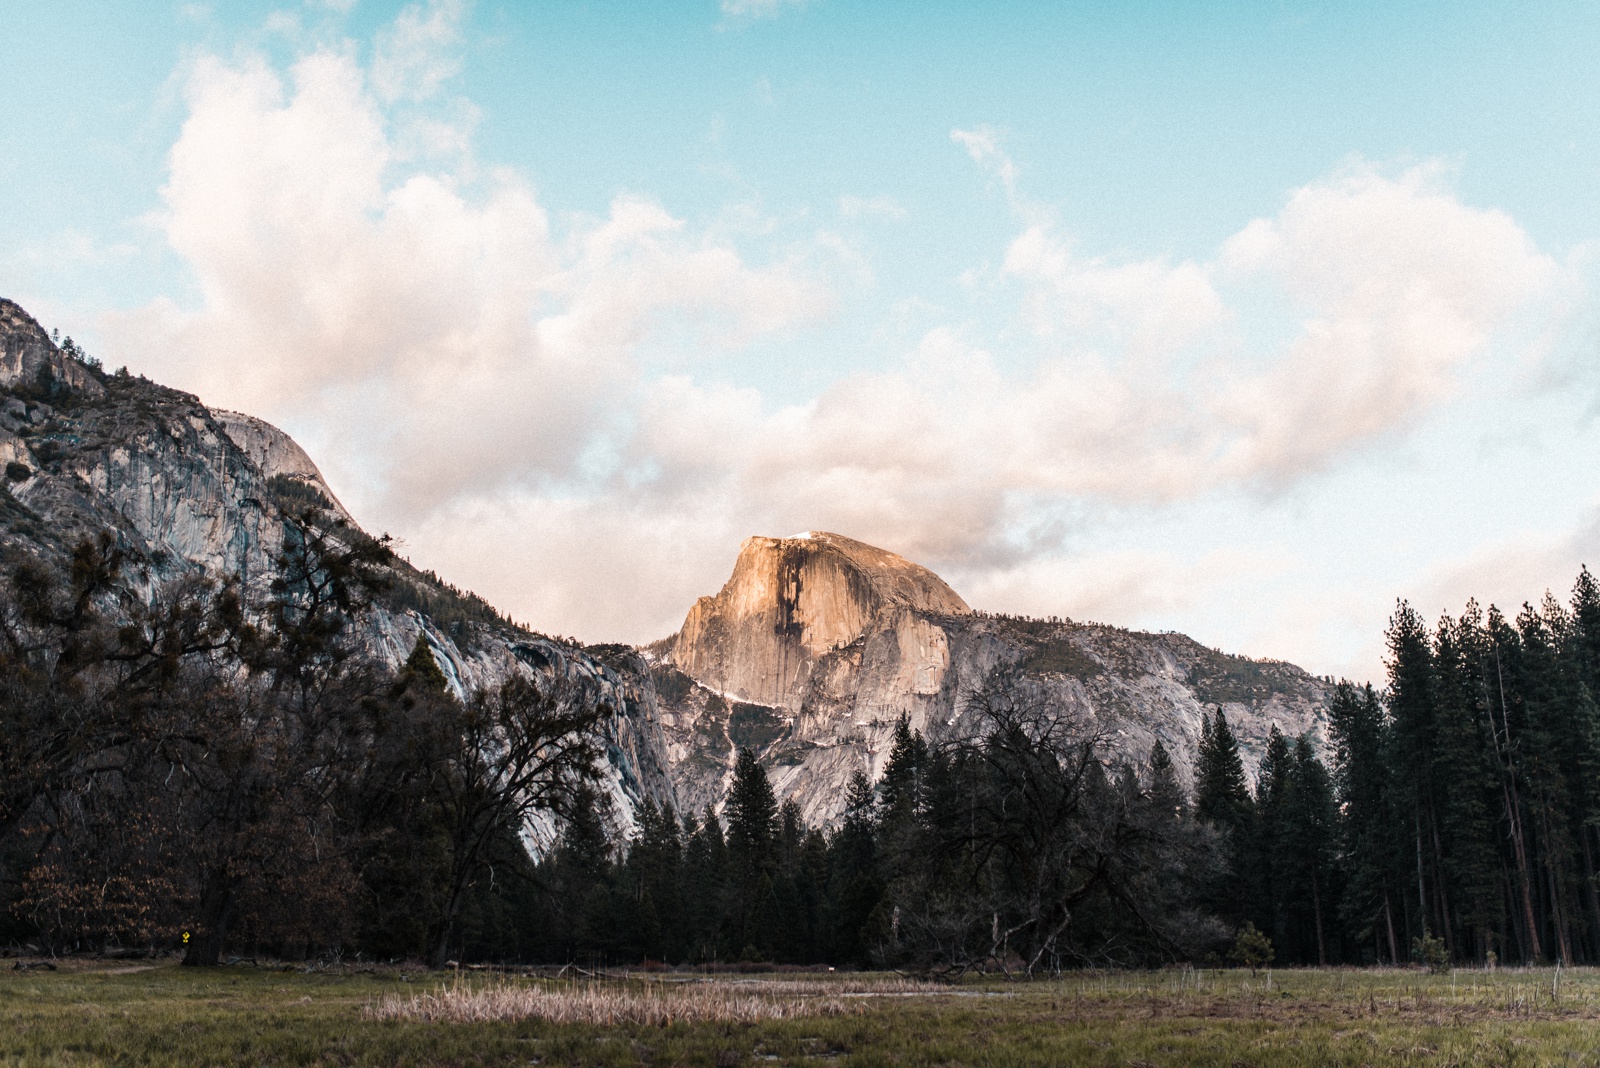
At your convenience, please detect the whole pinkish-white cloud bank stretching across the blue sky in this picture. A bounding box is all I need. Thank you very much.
[107,16,1565,652]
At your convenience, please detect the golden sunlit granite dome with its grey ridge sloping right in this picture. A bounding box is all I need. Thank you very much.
[646,532,1330,823]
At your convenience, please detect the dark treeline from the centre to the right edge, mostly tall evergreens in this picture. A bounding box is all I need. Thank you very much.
[502,569,1600,970]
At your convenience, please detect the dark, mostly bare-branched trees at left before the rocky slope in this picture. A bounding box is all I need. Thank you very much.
[0,508,610,964]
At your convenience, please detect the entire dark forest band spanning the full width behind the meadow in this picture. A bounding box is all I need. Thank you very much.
[9,504,1600,977]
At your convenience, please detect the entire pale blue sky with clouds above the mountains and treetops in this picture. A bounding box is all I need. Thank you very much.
[0,0,1600,683]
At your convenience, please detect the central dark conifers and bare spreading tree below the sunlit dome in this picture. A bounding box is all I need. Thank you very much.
[505,700,1229,974]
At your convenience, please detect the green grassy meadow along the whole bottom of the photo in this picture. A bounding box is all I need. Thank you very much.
[0,962,1600,1068]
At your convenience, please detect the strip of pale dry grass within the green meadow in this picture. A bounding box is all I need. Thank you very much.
[365,982,850,1026]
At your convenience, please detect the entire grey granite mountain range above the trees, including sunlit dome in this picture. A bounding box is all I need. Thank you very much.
[0,299,1328,843]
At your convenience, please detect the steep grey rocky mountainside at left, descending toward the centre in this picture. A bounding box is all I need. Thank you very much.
[0,299,675,839]
